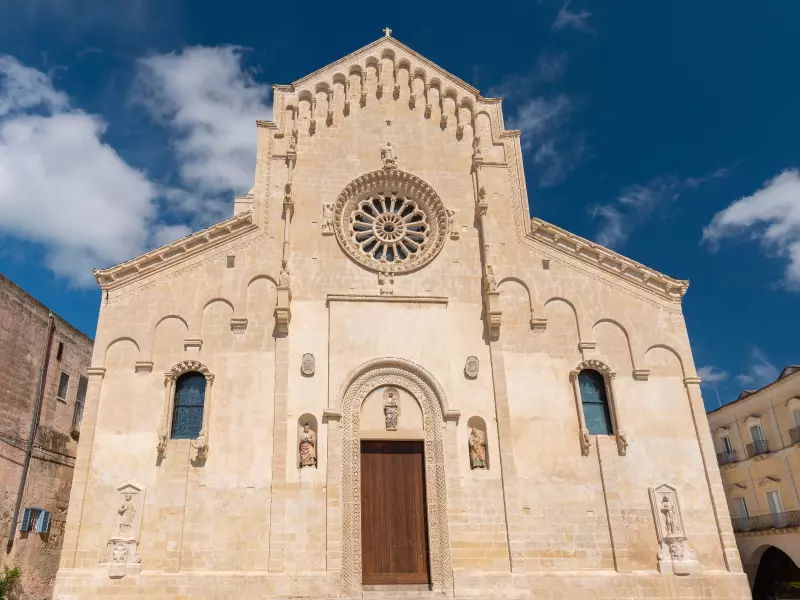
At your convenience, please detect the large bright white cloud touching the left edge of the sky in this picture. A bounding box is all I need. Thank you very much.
[0,56,186,285]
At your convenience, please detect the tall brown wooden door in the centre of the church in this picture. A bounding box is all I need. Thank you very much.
[361,441,430,585]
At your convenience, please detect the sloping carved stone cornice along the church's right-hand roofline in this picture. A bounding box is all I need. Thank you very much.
[529,218,689,302]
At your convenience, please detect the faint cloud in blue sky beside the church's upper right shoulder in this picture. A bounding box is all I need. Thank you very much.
[509,94,586,187]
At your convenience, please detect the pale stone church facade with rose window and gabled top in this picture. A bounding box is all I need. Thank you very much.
[55,32,749,600]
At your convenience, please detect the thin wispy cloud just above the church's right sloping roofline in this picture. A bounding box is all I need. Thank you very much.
[590,169,729,248]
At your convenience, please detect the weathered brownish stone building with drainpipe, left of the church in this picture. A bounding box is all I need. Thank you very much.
[0,275,92,600]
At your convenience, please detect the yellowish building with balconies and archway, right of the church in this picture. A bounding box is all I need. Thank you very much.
[708,366,800,596]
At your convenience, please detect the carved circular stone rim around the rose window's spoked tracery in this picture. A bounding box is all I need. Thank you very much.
[333,169,449,273]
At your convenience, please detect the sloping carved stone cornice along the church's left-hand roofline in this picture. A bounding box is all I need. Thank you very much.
[94,211,258,290]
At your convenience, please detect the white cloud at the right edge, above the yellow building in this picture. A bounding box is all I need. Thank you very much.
[702,169,800,291]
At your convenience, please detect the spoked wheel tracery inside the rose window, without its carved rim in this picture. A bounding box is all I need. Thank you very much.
[350,192,430,263]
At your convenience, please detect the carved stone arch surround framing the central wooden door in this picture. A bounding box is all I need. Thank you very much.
[326,358,459,595]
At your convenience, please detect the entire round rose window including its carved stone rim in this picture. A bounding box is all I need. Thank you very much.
[333,168,449,273]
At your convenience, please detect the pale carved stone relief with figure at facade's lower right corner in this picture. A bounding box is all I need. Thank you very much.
[650,484,701,575]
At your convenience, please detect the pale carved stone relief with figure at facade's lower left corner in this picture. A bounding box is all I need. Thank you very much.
[102,483,144,578]
